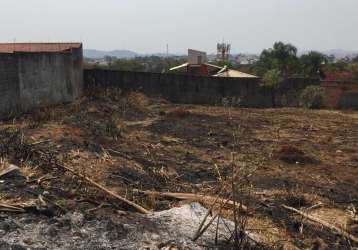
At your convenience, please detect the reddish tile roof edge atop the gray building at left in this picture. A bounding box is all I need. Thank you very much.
[0,43,82,53]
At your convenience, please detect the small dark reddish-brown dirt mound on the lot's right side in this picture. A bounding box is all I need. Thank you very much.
[276,145,317,164]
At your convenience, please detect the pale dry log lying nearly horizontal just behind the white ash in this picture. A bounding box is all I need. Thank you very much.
[135,190,247,212]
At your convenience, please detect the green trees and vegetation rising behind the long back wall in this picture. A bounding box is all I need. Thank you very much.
[86,42,358,82]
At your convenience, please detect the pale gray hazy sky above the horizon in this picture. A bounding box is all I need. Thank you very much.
[0,0,358,53]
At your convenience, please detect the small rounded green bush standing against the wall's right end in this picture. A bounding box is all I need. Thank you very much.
[300,85,324,109]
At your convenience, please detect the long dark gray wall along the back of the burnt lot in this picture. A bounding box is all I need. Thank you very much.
[84,69,319,107]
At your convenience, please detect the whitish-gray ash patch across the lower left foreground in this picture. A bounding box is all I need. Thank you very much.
[0,203,243,250]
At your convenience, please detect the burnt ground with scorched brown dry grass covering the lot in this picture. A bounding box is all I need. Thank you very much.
[0,90,358,249]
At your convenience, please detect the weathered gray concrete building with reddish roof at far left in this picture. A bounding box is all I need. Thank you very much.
[0,43,83,114]
